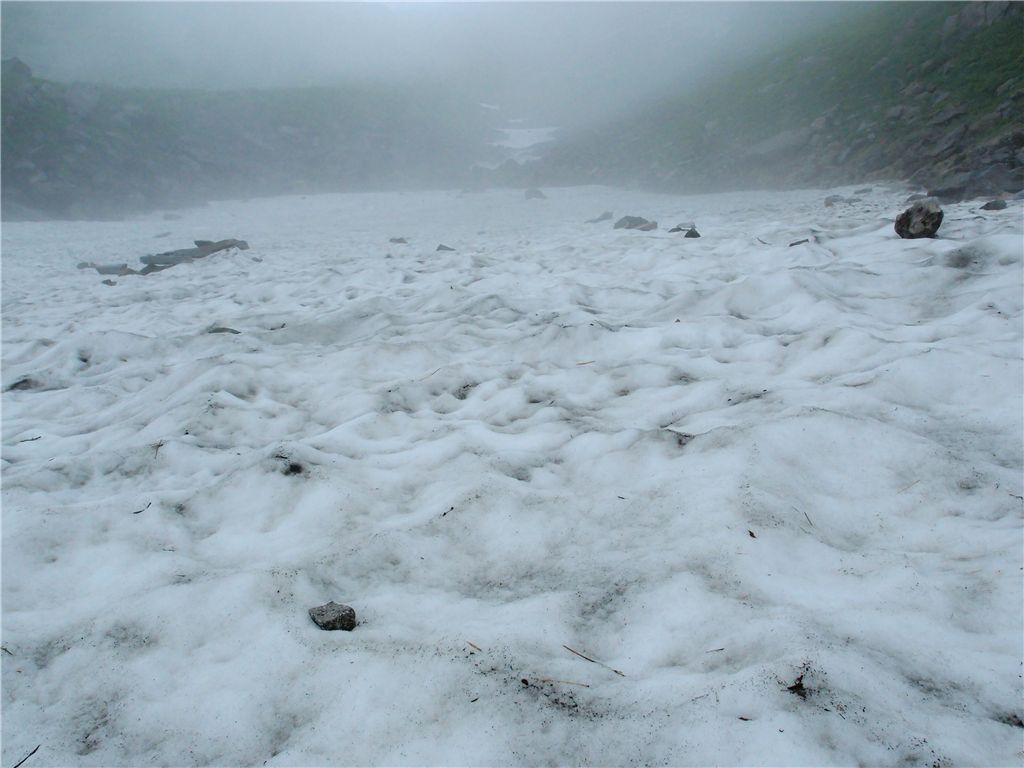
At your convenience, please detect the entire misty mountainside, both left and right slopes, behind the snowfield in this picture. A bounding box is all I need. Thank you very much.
[0,2,1024,219]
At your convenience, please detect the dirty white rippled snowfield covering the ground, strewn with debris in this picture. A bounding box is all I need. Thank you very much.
[6,187,1024,768]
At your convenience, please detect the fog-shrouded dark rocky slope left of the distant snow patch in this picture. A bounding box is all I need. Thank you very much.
[2,59,494,219]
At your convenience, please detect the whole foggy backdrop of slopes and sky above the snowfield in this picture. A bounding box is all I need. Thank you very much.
[2,2,1024,218]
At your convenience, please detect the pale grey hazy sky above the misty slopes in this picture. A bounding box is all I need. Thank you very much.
[0,2,856,122]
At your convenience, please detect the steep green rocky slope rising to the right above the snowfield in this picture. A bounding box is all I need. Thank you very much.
[536,2,1024,199]
